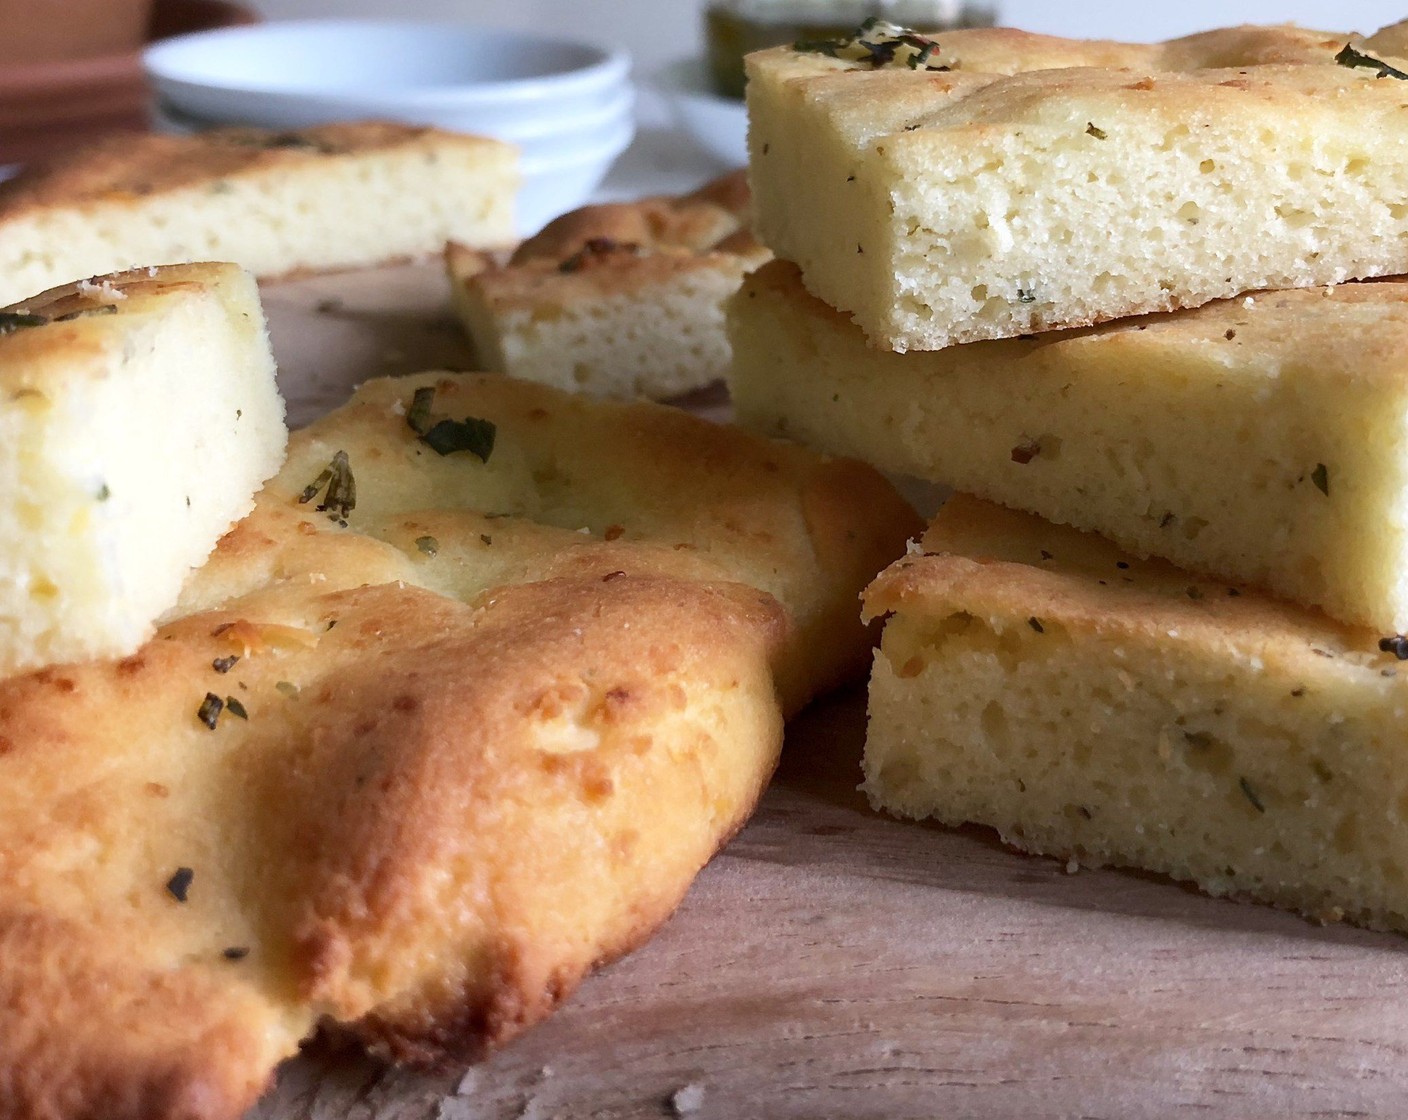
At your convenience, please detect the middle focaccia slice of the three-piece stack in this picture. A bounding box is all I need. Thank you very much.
[729,262,1408,633]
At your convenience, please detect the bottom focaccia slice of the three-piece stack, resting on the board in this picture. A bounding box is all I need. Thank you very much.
[865,496,1408,931]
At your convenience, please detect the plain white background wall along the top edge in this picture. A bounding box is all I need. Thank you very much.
[253,0,1408,60]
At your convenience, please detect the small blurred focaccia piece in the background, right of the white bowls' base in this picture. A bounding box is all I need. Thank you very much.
[445,172,772,400]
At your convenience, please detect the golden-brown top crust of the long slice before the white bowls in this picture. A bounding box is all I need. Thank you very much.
[0,121,503,221]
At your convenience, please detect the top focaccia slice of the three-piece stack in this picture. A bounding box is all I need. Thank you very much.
[748,18,1408,351]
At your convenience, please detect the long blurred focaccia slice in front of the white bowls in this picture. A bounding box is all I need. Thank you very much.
[0,121,518,303]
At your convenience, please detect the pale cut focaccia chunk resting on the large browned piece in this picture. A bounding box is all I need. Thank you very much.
[0,263,287,675]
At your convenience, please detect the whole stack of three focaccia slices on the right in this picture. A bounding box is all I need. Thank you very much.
[729,17,1408,931]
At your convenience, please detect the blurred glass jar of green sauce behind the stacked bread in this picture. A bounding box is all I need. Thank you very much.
[704,0,997,97]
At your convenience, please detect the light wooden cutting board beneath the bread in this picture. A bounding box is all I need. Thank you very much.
[249,266,1408,1120]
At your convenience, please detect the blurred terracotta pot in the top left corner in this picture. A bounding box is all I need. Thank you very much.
[0,0,258,165]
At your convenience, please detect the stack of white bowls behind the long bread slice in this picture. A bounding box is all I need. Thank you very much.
[144,20,635,235]
